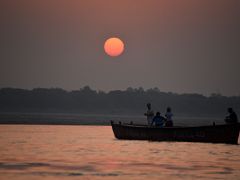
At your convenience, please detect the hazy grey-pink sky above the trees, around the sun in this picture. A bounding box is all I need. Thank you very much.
[0,0,240,95]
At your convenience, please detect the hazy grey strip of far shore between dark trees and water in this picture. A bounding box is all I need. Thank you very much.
[0,112,224,126]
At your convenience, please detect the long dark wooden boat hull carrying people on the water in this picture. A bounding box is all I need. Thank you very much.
[111,121,240,144]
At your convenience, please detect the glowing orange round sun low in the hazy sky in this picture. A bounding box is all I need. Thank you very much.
[104,37,124,57]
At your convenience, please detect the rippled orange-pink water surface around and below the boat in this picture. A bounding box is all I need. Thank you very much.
[0,125,240,180]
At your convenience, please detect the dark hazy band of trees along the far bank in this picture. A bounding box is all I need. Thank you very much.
[0,86,240,117]
